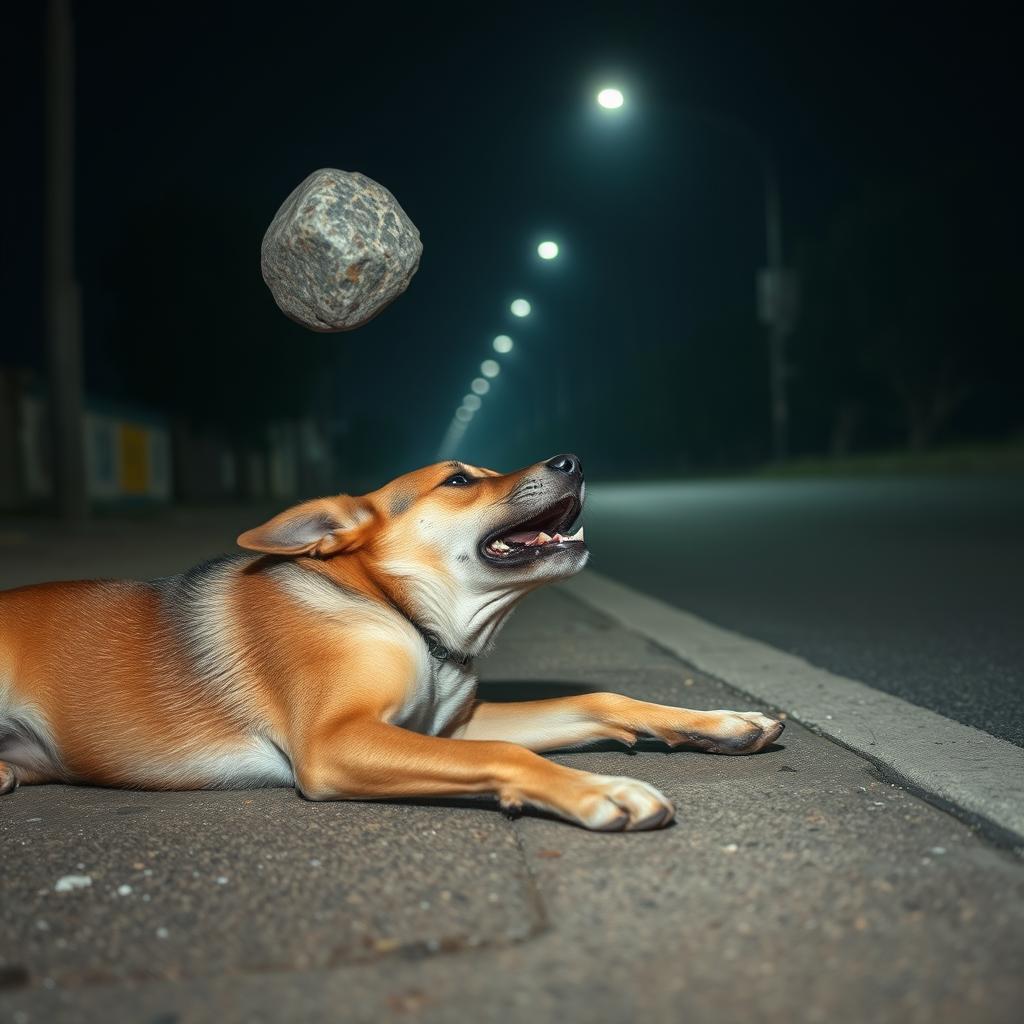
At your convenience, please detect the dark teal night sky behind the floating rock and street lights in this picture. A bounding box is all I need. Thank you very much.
[0,2,1020,477]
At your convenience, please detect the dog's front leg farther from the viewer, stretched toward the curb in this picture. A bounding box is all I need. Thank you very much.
[452,693,783,754]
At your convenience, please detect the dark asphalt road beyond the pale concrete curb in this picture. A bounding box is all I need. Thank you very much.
[584,478,1024,746]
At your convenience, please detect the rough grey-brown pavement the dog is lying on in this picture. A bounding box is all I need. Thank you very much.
[0,523,1024,1024]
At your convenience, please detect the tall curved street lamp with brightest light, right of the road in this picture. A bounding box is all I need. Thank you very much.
[596,88,800,462]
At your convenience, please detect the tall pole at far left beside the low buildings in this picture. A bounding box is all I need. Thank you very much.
[45,0,88,520]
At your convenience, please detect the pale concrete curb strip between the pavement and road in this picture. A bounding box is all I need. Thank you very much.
[562,571,1024,853]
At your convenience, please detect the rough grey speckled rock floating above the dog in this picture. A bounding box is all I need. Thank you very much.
[260,167,423,332]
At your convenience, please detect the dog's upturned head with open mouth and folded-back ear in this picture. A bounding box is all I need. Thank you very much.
[239,455,588,647]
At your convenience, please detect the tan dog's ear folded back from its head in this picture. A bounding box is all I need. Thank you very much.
[238,495,374,556]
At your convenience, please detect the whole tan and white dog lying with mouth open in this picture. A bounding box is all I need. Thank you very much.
[0,455,782,830]
